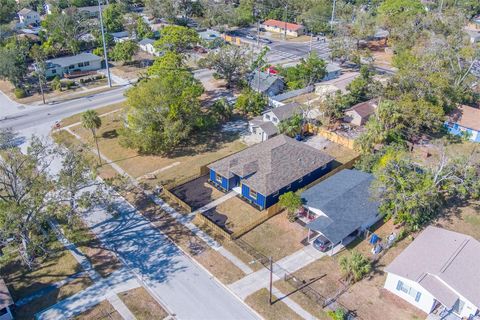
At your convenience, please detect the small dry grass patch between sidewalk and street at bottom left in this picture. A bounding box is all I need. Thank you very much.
[118,287,168,320]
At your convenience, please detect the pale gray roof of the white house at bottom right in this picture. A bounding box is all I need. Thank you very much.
[385,227,480,308]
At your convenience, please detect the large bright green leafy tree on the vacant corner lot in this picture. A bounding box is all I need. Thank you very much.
[121,69,203,153]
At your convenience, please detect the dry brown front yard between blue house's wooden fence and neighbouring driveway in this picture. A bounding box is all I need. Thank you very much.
[241,212,307,261]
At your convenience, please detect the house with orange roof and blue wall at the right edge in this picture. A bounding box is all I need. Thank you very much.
[445,105,480,142]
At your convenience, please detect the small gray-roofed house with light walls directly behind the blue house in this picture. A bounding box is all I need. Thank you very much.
[248,102,302,142]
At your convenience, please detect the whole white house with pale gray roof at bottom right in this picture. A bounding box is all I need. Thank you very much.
[385,227,480,319]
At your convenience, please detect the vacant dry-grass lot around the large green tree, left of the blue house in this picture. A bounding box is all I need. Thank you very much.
[66,106,246,187]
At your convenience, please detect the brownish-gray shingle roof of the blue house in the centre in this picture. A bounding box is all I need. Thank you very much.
[208,135,333,196]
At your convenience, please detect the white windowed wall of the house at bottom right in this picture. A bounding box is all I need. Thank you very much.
[384,272,436,314]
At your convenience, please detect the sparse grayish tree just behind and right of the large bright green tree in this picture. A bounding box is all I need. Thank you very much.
[200,45,251,88]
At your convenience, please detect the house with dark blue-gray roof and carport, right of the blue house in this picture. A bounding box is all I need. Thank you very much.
[301,169,382,249]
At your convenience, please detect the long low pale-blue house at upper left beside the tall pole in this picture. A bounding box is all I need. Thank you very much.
[42,52,102,78]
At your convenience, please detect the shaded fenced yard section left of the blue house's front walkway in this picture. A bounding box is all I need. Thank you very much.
[170,175,224,211]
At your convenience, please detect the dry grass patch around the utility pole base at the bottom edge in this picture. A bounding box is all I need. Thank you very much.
[245,289,302,320]
